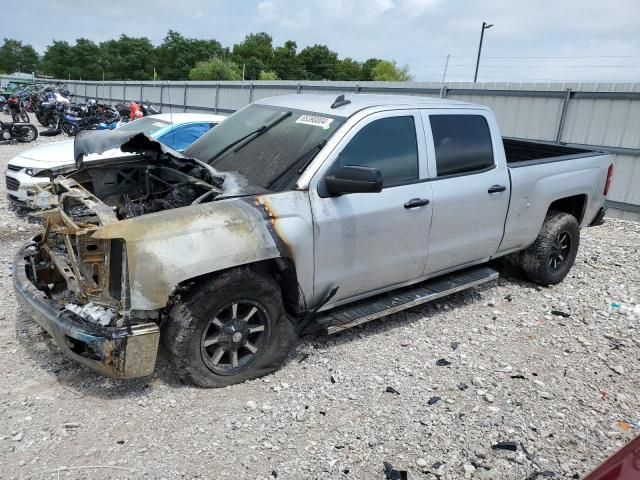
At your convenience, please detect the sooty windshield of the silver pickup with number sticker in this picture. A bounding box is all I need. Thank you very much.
[184,105,345,190]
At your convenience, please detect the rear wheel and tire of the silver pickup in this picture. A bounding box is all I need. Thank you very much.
[517,211,580,285]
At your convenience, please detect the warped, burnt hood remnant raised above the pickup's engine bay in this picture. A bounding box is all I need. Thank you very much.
[73,130,186,169]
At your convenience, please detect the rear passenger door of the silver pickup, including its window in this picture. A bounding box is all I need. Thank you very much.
[422,109,511,275]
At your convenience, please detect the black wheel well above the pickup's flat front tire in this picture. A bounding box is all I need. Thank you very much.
[170,258,307,318]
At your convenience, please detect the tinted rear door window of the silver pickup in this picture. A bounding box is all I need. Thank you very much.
[429,115,493,177]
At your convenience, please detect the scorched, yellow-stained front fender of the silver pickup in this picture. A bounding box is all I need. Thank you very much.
[93,197,289,310]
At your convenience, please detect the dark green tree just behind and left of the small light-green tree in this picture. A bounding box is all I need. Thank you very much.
[152,30,229,80]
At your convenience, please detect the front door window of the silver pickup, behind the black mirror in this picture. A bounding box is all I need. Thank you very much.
[331,116,418,187]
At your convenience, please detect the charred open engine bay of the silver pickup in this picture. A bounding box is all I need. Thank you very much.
[65,159,224,220]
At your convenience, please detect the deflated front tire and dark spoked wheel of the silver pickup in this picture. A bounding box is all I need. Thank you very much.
[161,268,295,388]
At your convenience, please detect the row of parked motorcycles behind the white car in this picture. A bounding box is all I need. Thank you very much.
[0,80,160,142]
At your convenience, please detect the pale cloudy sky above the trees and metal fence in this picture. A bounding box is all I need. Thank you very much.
[6,0,640,82]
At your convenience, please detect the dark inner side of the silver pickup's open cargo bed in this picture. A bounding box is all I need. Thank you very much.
[502,137,603,168]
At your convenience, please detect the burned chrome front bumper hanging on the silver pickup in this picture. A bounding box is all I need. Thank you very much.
[13,242,160,378]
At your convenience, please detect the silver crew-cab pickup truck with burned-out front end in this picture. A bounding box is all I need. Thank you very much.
[13,95,612,387]
